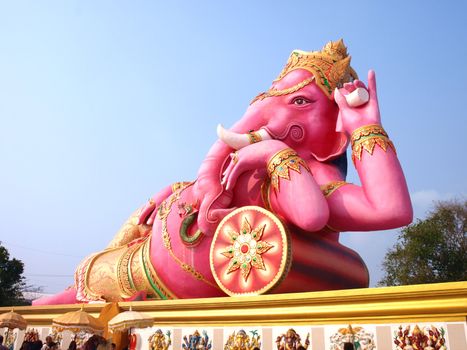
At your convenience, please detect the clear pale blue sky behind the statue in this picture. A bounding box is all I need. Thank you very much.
[0,1,467,292]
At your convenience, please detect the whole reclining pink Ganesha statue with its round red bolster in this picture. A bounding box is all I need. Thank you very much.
[34,40,412,305]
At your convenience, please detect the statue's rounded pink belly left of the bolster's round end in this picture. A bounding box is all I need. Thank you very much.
[151,183,225,298]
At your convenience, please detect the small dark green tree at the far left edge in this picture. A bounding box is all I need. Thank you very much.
[0,242,26,306]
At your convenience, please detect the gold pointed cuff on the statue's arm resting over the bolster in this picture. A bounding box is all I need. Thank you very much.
[267,148,310,192]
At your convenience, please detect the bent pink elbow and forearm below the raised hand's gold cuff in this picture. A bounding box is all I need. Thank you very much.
[327,141,413,231]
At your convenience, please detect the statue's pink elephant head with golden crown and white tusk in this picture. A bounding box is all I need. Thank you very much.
[221,39,357,168]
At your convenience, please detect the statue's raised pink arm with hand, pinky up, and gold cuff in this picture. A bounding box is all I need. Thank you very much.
[327,71,413,231]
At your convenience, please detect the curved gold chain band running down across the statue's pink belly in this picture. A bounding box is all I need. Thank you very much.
[157,183,219,288]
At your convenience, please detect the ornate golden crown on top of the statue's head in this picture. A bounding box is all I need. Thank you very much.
[274,39,358,98]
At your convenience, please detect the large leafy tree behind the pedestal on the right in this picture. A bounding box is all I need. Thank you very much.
[378,201,467,286]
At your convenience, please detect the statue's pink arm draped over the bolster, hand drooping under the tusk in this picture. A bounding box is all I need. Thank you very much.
[223,140,329,231]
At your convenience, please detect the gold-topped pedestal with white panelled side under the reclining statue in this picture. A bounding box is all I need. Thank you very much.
[0,281,467,350]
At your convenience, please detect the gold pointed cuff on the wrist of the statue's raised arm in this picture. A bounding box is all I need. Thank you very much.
[350,124,396,164]
